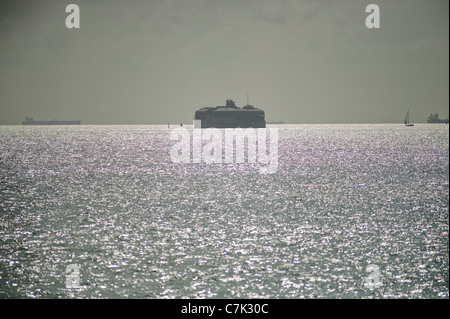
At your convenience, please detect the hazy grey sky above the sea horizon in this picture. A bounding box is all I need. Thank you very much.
[0,0,449,124]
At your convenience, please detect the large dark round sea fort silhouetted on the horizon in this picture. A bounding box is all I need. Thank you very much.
[194,100,266,128]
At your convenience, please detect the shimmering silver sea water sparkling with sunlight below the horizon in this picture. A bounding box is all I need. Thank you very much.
[0,124,449,298]
